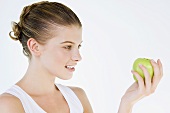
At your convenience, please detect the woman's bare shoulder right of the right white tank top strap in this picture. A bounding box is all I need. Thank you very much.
[69,86,93,113]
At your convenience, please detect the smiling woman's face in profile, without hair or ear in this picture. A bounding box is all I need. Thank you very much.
[40,26,82,80]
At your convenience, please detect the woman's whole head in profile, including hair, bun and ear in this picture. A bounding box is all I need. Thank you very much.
[9,1,82,79]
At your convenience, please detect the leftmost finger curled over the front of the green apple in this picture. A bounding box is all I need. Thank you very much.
[131,70,145,91]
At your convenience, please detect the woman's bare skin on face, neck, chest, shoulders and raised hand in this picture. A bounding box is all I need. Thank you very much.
[0,26,163,113]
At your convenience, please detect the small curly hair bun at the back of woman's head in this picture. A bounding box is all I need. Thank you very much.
[9,21,21,41]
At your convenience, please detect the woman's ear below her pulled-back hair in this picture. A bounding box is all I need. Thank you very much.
[27,38,41,56]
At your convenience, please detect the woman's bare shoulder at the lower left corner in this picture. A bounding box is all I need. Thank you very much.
[0,93,24,113]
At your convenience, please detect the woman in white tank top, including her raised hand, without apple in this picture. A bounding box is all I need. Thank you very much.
[0,1,163,113]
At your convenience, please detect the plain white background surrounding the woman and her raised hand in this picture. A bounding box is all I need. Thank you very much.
[0,0,170,113]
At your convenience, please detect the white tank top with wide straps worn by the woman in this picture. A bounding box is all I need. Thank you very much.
[5,84,84,113]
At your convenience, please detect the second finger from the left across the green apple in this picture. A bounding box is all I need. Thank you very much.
[139,65,151,92]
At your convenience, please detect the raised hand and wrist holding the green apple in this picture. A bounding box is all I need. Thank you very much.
[118,60,163,113]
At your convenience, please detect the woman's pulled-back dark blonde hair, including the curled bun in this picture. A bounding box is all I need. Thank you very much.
[9,1,82,59]
